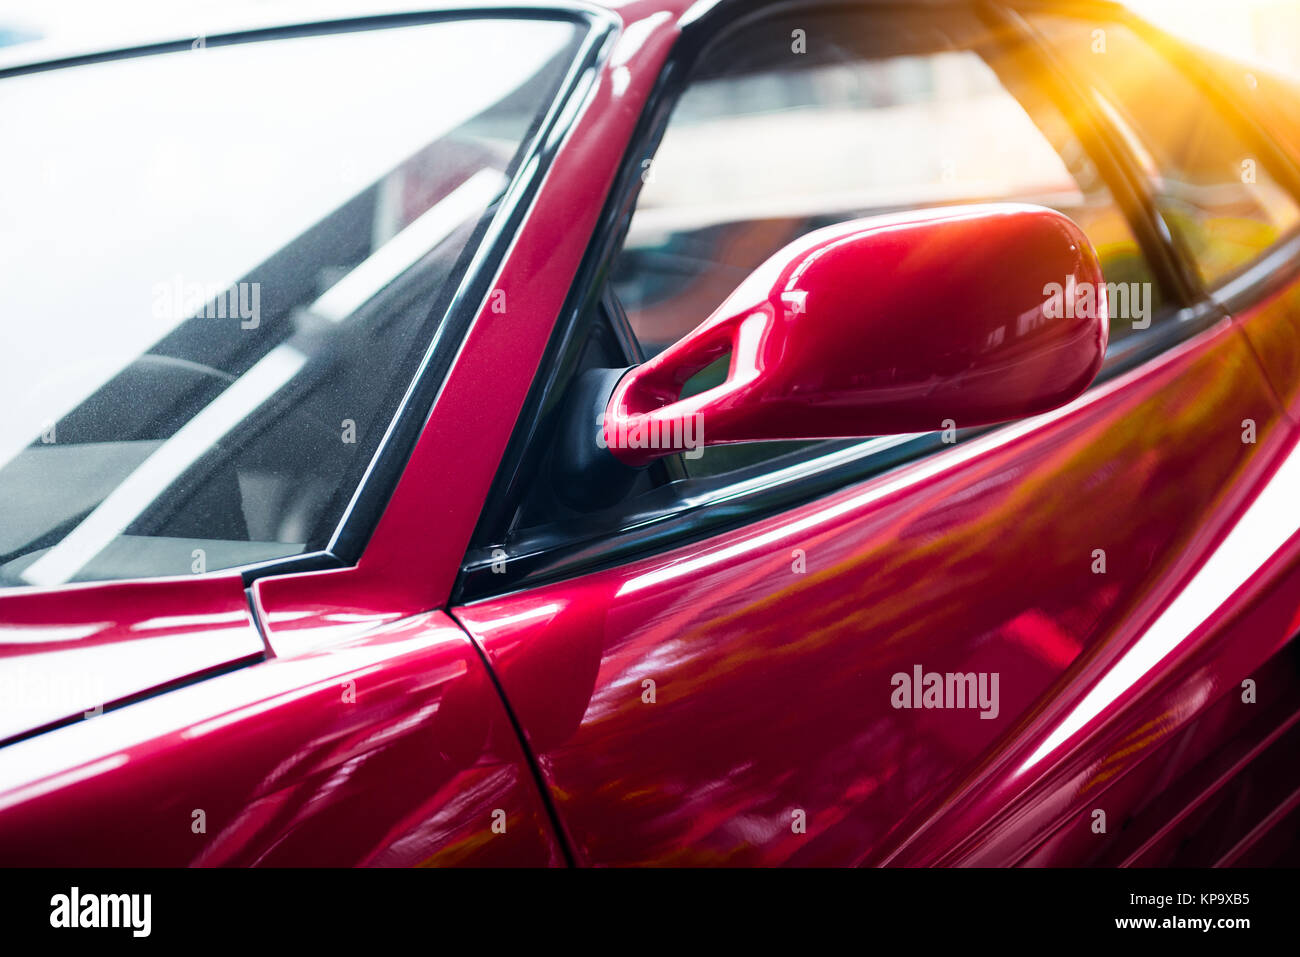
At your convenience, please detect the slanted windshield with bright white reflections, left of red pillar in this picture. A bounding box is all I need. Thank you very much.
[0,18,577,585]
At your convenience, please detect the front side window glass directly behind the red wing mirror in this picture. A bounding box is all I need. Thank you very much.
[611,12,1160,476]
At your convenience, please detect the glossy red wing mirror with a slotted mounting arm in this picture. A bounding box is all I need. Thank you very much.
[605,203,1108,465]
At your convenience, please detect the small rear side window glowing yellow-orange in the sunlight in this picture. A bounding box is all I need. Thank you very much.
[1030,14,1300,286]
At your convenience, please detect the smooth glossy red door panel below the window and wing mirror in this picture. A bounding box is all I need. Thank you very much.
[454,321,1290,865]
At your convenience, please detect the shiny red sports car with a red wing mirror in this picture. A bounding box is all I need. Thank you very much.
[0,0,1300,866]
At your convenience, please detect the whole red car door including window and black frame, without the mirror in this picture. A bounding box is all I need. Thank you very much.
[452,5,1297,865]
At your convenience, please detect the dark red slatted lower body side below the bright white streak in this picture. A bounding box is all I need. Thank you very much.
[967,546,1300,867]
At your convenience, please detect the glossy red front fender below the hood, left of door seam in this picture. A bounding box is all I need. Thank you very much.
[0,612,563,866]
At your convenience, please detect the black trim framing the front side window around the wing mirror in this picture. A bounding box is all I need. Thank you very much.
[451,0,1290,605]
